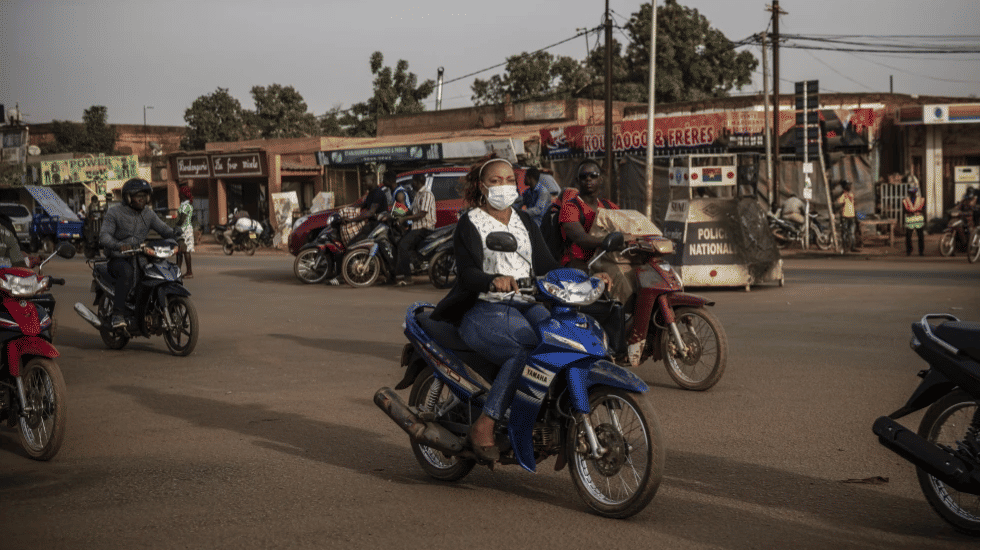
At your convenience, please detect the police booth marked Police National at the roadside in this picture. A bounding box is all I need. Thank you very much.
[664,154,784,290]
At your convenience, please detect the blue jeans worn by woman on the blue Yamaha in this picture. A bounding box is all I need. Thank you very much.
[460,300,549,420]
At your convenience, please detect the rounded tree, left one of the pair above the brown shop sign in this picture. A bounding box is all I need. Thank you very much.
[181,88,249,151]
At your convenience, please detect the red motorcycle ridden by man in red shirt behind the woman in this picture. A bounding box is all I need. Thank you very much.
[594,235,729,391]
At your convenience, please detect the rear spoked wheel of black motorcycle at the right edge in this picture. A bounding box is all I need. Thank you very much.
[916,390,978,536]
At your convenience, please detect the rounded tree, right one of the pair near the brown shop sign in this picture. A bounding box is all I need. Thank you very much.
[245,84,318,139]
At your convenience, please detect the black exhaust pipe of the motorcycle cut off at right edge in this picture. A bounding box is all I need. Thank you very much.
[872,416,978,495]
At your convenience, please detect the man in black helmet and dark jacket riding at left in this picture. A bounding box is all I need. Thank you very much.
[99,178,175,328]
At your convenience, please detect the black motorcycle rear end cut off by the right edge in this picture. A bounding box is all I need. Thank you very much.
[872,314,979,536]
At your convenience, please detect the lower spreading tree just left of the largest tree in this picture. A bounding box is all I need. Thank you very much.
[470,51,593,105]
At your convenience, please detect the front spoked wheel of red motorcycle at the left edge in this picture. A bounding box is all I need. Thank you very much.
[17,357,68,460]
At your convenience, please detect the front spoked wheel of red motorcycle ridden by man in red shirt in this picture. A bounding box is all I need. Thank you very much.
[661,307,729,391]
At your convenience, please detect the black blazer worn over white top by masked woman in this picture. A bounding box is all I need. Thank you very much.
[432,210,562,324]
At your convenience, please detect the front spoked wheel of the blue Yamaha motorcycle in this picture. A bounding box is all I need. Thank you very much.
[565,386,665,518]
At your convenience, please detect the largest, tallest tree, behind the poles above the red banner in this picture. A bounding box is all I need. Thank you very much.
[626,0,758,103]
